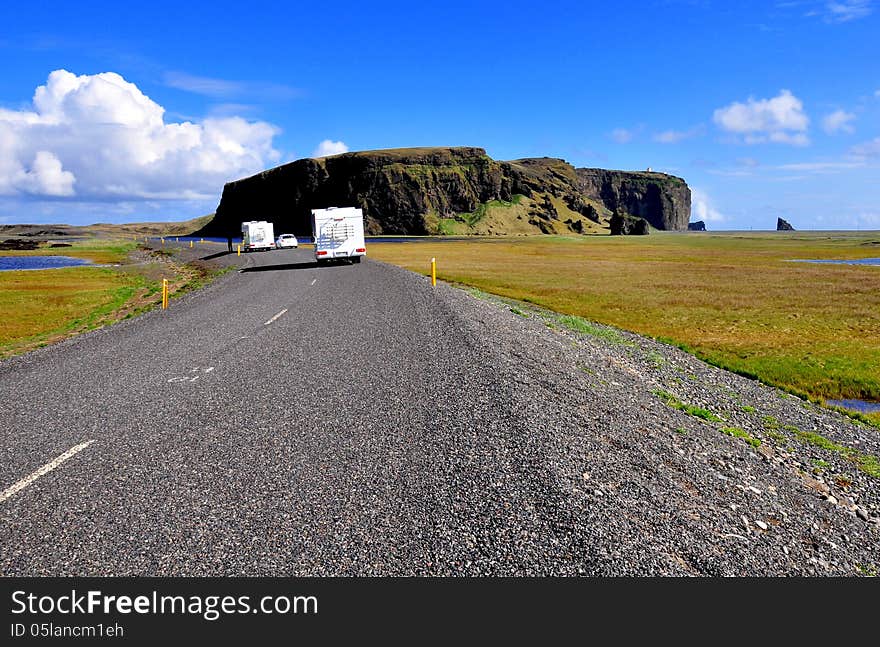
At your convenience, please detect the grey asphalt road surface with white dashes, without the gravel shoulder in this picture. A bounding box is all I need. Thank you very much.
[0,250,596,575]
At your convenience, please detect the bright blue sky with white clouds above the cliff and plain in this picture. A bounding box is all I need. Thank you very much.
[0,0,880,229]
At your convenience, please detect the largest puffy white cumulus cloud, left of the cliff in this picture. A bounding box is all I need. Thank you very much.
[0,70,280,199]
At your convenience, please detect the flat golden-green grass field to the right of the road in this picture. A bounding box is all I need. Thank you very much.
[368,232,880,400]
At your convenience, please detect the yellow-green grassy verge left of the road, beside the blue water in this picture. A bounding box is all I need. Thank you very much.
[0,240,222,359]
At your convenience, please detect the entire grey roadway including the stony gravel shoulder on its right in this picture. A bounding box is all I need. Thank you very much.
[0,244,880,576]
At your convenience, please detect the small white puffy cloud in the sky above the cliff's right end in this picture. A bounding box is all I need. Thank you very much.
[712,90,810,146]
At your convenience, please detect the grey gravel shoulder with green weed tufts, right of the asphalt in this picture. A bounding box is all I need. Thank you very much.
[412,264,880,575]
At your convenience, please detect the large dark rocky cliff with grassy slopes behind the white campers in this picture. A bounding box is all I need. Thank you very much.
[196,147,690,236]
